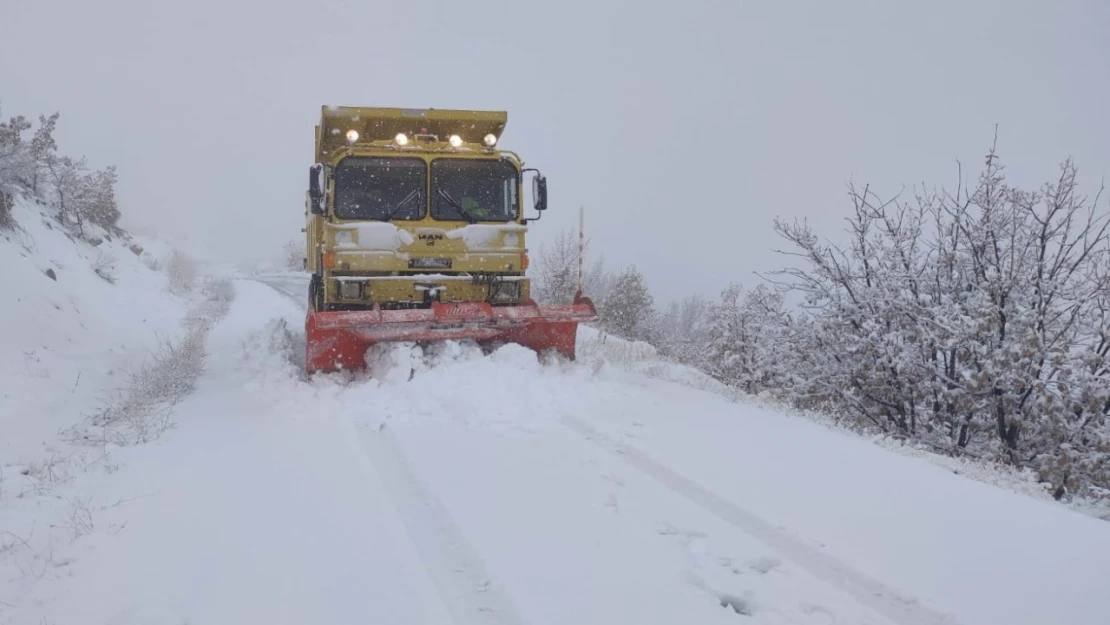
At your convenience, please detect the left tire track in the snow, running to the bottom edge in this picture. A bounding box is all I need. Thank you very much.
[355,425,525,625]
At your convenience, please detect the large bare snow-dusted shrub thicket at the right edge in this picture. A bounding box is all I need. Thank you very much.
[754,142,1110,497]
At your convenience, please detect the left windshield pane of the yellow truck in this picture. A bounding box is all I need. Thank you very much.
[335,157,427,220]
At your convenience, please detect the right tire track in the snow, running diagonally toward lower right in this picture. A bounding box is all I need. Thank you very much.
[559,415,958,625]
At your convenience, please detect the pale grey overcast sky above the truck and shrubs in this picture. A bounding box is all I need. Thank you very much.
[0,0,1110,300]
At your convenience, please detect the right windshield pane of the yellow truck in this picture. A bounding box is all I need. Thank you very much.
[432,159,519,223]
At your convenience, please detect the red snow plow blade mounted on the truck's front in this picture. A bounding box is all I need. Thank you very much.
[304,296,597,374]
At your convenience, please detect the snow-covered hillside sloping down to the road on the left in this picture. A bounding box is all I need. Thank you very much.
[0,195,236,623]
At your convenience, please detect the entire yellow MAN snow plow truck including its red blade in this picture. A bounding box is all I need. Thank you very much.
[305,105,596,374]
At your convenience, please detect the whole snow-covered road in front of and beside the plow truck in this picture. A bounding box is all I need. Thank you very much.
[11,276,1110,625]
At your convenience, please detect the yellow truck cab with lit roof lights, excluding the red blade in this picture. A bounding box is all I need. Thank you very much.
[305,107,547,311]
